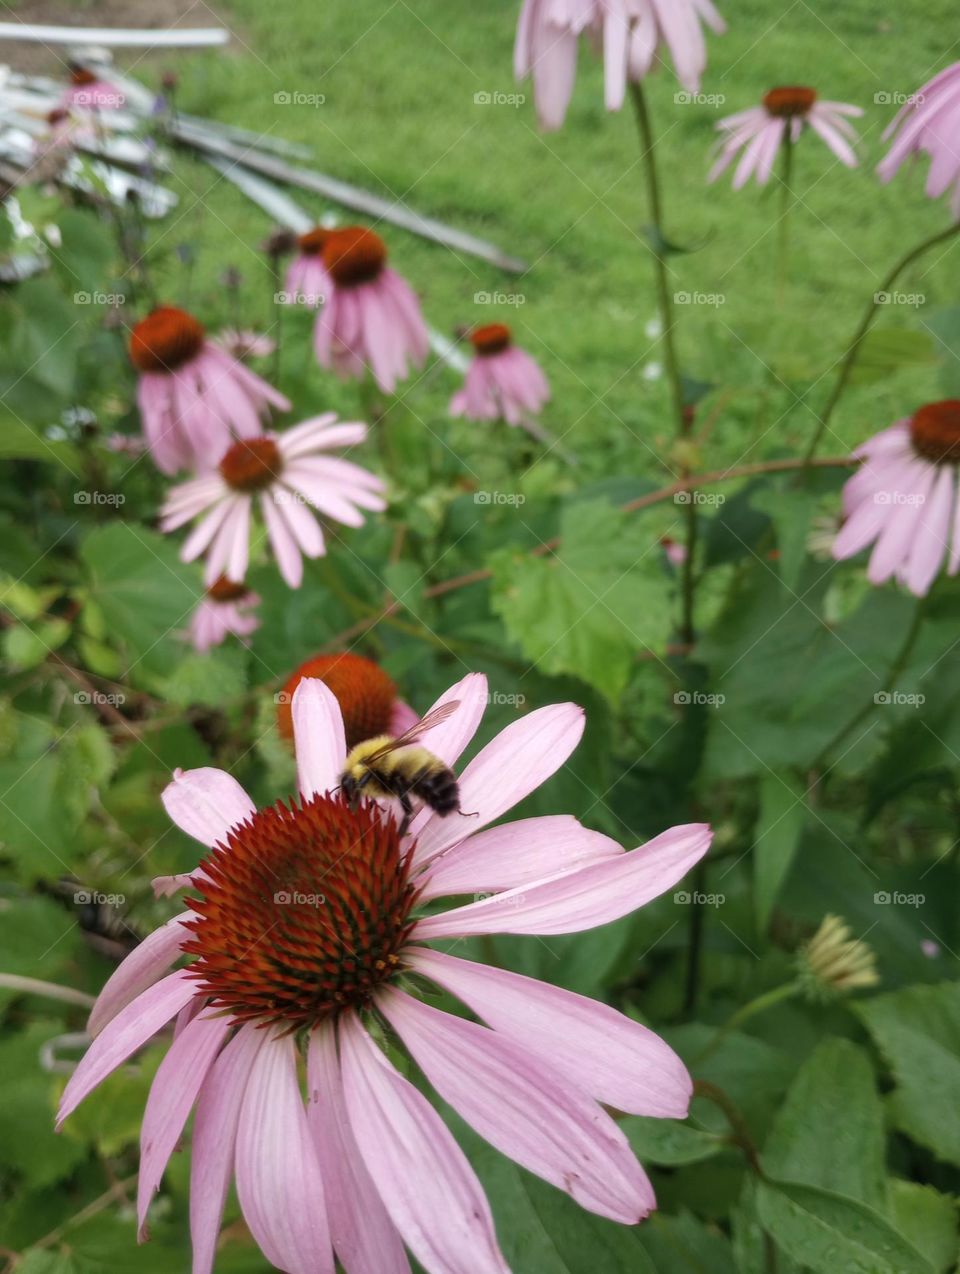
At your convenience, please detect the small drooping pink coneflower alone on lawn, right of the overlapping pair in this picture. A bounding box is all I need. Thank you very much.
[449,322,550,424]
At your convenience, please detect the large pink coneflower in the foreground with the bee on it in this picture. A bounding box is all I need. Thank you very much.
[59,675,710,1274]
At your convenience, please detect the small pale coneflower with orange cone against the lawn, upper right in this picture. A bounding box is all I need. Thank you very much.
[707,85,863,190]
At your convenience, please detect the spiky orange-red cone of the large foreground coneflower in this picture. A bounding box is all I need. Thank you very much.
[183,795,416,1031]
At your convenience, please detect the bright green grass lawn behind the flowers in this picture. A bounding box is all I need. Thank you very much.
[131,0,957,496]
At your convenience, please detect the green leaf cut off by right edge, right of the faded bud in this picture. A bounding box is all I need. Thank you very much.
[853,982,960,1163]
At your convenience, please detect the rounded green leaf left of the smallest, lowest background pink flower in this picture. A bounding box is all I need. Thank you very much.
[80,522,202,675]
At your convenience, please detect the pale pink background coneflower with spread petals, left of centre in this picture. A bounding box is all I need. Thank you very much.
[160,412,386,589]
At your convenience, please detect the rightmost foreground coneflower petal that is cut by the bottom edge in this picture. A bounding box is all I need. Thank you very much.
[340,1014,509,1274]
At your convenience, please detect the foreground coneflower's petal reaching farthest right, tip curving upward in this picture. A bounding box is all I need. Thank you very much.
[415,823,713,941]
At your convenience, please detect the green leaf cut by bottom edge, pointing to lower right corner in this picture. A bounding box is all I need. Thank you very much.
[756,1181,933,1274]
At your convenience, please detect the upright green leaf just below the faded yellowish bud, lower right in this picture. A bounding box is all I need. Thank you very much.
[763,1040,886,1209]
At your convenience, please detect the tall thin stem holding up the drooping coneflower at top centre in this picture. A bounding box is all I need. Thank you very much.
[630,80,696,645]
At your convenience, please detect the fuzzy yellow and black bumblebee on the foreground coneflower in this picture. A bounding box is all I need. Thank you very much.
[340,699,460,836]
